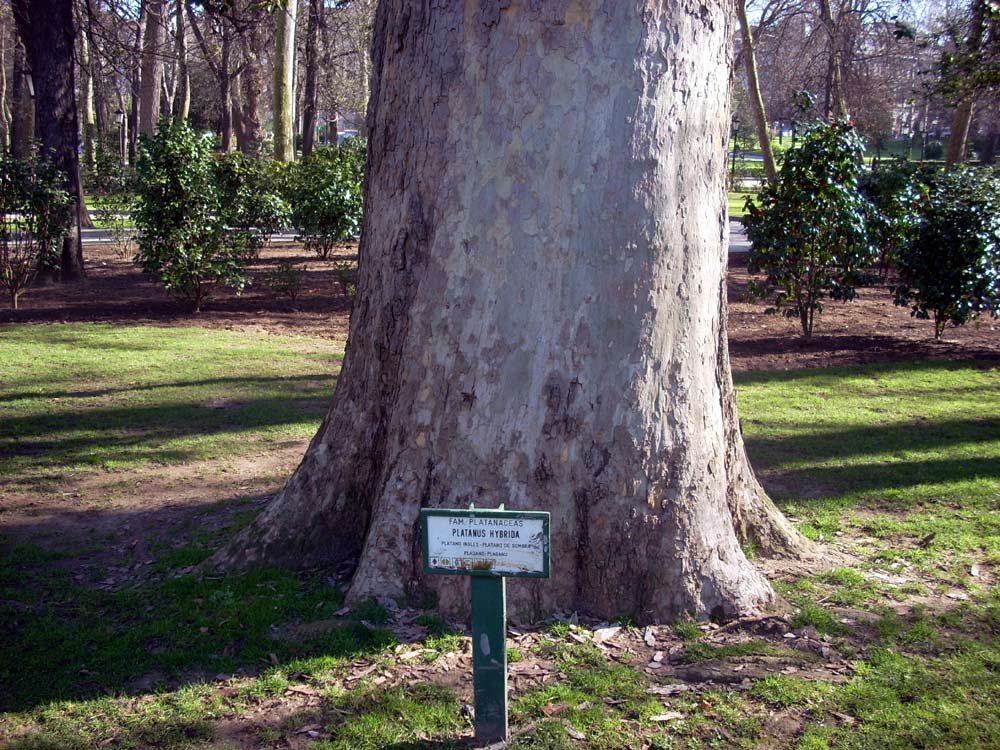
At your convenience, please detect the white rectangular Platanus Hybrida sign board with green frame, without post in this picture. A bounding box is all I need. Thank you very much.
[423,510,549,578]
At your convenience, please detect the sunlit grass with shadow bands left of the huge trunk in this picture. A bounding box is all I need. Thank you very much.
[0,324,342,491]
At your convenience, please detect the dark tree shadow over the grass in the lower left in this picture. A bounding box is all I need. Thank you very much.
[0,494,395,711]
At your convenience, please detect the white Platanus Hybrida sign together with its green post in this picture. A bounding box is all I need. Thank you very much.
[420,506,549,743]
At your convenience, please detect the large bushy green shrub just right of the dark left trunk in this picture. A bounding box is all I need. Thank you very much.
[136,118,263,312]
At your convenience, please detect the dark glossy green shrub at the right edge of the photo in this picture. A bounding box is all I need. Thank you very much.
[894,169,1000,338]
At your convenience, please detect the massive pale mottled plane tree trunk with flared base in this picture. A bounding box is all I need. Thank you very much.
[214,0,805,622]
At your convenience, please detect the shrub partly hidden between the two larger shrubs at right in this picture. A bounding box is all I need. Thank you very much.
[858,159,927,281]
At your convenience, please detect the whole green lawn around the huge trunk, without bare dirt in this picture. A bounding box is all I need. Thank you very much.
[0,325,1000,750]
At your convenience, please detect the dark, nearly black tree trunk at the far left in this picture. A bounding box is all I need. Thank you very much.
[13,0,86,281]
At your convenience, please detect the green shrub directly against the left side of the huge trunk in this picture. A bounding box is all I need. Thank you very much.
[287,144,364,260]
